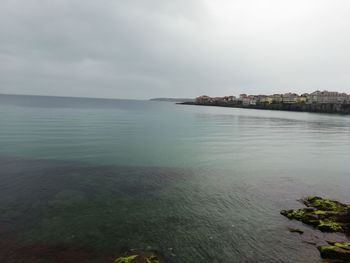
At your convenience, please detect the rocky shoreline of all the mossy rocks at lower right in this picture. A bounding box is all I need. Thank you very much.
[280,196,350,262]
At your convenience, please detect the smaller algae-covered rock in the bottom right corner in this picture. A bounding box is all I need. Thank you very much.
[318,242,350,262]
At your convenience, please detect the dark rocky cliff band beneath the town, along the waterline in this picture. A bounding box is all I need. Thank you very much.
[177,102,350,115]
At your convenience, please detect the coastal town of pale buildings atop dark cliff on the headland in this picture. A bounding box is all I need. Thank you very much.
[183,90,350,114]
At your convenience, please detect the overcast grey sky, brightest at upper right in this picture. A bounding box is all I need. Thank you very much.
[0,0,350,99]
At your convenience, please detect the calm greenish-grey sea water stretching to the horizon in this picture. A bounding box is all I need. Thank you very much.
[0,95,350,263]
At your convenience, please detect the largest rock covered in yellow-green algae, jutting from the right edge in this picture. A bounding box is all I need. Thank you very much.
[281,196,350,233]
